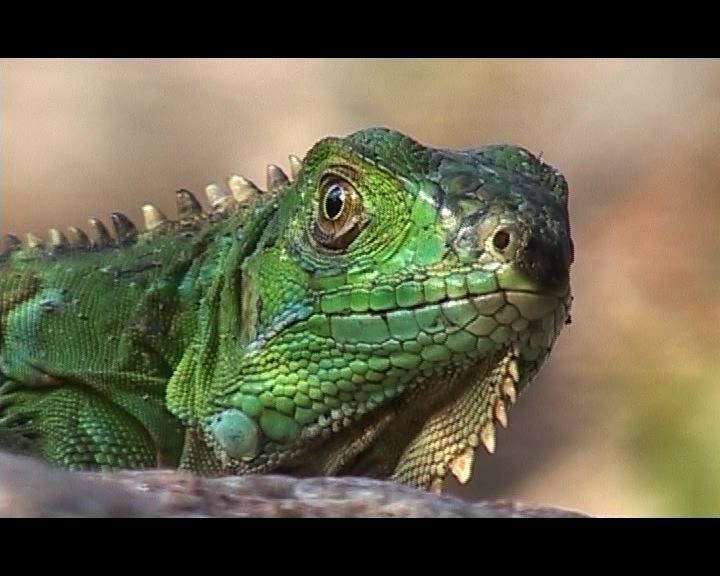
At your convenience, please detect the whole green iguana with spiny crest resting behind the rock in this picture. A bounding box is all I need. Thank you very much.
[0,128,573,489]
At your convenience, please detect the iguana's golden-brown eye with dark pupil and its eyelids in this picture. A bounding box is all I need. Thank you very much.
[314,175,362,250]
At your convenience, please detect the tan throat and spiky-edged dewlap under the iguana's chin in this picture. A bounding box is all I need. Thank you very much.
[296,291,569,490]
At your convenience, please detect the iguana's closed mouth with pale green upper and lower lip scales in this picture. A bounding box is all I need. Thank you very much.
[247,269,570,353]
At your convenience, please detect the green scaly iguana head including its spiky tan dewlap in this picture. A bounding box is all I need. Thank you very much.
[204,129,573,487]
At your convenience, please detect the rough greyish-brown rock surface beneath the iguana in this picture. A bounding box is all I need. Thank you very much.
[0,454,583,518]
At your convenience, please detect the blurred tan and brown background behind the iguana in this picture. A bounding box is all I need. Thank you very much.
[0,60,720,515]
